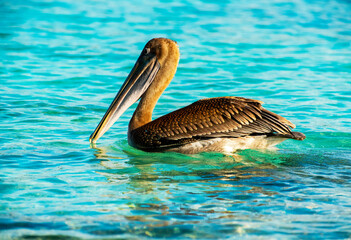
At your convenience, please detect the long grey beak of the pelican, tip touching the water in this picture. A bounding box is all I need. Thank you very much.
[89,51,160,143]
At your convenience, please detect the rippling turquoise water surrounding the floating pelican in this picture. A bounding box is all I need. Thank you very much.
[0,0,351,239]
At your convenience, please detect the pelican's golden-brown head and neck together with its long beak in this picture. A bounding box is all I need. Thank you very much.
[89,38,179,143]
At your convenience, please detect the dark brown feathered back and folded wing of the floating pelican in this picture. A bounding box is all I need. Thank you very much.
[130,97,305,151]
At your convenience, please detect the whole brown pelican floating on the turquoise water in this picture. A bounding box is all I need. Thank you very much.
[89,38,306,154]
